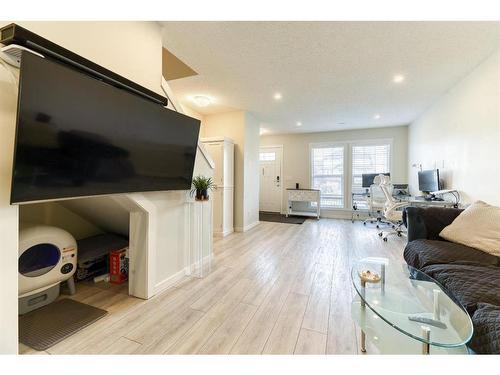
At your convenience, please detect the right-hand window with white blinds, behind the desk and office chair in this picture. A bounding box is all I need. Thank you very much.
[352,143,391,207]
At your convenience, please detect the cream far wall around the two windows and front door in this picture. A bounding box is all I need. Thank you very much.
[260,126,408,216]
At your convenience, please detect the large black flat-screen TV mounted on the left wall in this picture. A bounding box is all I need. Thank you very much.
[11,53,200,203]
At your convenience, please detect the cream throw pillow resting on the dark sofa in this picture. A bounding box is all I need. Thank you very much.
[439,201,500,257]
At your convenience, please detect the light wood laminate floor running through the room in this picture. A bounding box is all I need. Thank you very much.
[19,219,405,354]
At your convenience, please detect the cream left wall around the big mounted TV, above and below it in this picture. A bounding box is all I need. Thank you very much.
[0,22,211,353]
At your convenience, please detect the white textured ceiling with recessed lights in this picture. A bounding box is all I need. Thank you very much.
[161,22,500,133]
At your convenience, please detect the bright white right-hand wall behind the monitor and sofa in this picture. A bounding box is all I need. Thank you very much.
[408,50,500,205]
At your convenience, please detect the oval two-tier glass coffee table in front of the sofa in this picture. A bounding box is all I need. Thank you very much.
[351,258,473,354]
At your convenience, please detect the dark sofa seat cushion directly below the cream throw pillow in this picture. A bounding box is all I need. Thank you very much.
[403,240,500,269]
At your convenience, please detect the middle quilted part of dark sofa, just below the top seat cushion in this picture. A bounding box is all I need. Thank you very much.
[422,263,500,316]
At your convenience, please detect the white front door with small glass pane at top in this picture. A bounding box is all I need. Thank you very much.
[259,147,282,212]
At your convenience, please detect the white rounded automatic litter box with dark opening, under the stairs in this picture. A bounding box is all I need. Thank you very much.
[18,224,77,314]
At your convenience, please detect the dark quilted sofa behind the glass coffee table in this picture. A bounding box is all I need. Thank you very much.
[403,207,500,354]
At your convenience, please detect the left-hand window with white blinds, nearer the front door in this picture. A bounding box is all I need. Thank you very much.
[311,145,344,208]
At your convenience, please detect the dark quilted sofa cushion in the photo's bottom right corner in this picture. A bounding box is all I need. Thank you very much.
[469,303,500,354]
